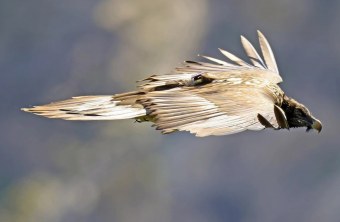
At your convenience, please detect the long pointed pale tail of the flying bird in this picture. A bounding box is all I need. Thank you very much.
[22,96,146,120]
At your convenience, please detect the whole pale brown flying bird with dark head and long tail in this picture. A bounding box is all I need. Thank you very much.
[22,31,322,137]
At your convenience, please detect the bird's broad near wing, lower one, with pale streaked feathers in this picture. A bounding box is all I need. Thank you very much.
[144,82,279,137]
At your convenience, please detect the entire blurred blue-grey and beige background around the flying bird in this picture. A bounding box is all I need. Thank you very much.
[0,0,340,222]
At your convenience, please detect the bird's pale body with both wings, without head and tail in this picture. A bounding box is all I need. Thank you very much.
[140,31,285,136]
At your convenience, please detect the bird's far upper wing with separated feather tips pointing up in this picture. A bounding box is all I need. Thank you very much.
[140,31,282,90]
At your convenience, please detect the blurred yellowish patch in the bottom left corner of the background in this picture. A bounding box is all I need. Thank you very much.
[0,172,98,222]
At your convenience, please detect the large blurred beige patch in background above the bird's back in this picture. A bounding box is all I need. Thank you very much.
[94,0,209,84]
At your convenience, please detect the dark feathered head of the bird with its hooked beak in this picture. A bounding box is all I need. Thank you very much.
[282,97,322,133]
